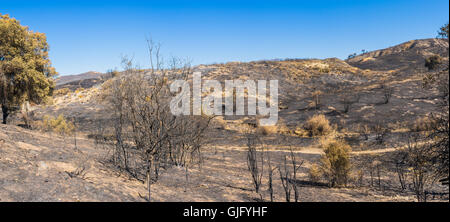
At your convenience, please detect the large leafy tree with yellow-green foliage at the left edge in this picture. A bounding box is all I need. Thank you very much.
[0,14,57,124]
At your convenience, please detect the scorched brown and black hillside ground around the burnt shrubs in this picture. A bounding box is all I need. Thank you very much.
[0,39,448,201]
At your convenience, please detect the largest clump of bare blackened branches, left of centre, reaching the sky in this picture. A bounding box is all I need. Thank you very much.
[105,40,212,201]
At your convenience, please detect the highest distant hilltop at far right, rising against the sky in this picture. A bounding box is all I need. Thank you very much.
[346,38,448,71]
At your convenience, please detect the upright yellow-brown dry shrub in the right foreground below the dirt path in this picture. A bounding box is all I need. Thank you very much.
[320,141,351,187]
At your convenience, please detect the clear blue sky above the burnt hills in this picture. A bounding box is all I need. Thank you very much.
[0,0,449,75]
